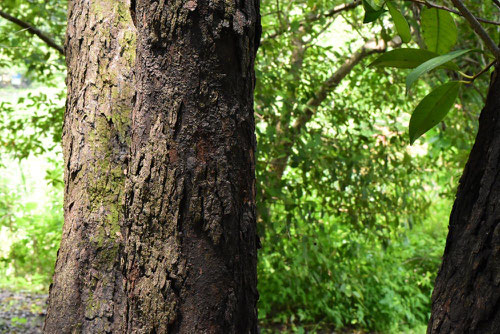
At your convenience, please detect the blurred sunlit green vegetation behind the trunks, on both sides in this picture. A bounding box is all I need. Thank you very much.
[0,0,498,333]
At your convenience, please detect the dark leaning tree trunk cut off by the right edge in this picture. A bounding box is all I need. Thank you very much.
[428,69,500,333]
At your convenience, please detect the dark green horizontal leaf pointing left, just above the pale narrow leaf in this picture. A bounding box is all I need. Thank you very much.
[369,48,459,70]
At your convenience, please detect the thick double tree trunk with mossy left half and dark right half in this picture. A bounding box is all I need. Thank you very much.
[45,0,260,333]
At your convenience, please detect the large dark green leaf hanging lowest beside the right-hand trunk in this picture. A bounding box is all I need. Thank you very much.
[410,81,462,145]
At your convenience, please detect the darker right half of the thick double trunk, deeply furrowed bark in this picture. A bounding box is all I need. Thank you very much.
[124,0,260,333]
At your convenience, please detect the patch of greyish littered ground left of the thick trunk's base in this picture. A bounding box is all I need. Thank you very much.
[0,290,47,334]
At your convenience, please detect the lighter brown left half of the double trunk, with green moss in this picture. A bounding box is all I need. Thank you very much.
[44,0,135,333]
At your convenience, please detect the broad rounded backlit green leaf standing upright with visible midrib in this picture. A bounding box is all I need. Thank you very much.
[420,7,458,54]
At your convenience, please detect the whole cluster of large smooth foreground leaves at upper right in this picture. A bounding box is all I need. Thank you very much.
[363,0,498,144]
